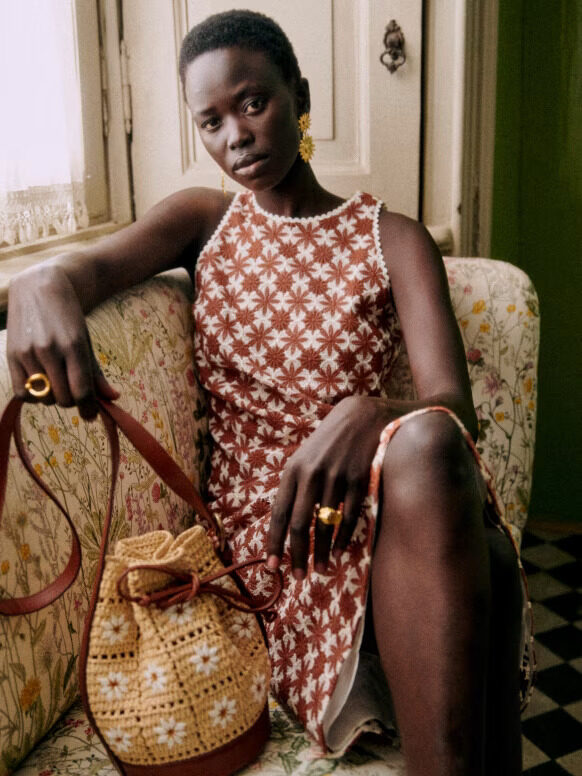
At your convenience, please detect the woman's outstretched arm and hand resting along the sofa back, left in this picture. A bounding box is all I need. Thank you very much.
[7,189,228,418]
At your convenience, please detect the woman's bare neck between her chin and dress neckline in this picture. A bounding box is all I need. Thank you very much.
[255,157,343,218]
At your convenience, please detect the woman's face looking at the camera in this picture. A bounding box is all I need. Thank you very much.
[184,47,299,191]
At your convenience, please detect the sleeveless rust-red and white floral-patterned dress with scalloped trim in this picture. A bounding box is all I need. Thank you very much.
[194,192,529,755]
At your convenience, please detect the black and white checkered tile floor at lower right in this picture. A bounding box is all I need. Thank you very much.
[522,527,582,776]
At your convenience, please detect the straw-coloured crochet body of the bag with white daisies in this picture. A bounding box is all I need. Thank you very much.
[86,526,270,767]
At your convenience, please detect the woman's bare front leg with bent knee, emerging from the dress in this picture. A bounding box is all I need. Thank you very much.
[372,413,492,776]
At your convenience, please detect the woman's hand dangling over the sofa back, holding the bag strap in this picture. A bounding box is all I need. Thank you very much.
[7,263,119,420]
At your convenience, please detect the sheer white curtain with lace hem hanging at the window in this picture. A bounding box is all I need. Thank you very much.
[0,0,89,248]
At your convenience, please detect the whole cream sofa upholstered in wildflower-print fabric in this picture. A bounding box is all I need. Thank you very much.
[0,258,539,776]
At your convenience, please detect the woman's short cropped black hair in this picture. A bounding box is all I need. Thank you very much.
[179,9,301,84]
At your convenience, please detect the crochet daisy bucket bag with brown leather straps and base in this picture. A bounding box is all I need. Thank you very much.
[0,398,282,776]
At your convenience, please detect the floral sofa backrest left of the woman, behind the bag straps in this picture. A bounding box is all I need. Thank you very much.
[0,276,206,776]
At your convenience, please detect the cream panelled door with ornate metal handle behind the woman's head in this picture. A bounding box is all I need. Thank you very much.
[123,0,422,218]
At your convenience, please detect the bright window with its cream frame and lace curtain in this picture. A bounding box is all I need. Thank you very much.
[0,0,129,256]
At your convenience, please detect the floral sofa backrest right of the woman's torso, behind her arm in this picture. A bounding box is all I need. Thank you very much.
[388,258,539,542]
